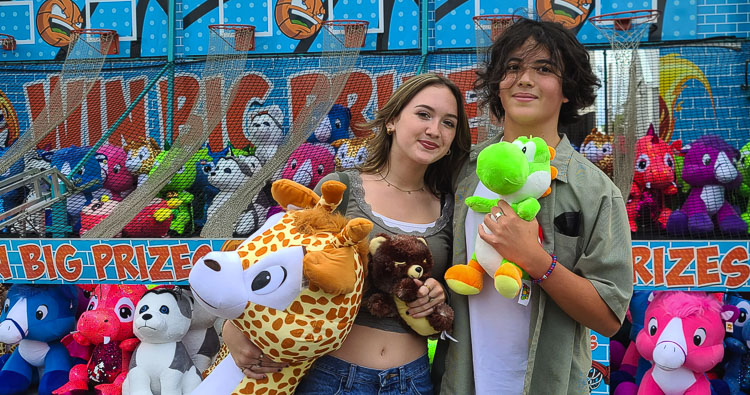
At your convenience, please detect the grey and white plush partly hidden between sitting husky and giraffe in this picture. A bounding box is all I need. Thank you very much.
[182,288,221,373]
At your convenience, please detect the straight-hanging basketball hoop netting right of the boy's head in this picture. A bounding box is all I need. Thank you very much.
[590,10,659,201]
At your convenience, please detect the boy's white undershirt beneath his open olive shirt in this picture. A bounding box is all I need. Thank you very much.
[465,182,531,395]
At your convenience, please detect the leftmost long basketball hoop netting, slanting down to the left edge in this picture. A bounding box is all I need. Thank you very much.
[0,31,116,173]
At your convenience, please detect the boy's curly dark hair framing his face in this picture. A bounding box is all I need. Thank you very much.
[474,18,601,125]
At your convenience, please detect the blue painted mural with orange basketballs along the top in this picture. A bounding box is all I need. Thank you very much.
[0,0,716,61]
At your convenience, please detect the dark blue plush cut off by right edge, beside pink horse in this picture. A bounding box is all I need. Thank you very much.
[724,294,750,395]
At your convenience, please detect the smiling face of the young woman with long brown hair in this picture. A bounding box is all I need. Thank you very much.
[386,85,458,165]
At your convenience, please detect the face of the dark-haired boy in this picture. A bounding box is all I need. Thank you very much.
[499,38,568,128]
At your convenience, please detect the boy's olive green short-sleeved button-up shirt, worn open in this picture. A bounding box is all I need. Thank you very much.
[432,136,633,395]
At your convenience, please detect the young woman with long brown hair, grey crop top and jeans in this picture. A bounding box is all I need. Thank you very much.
[223,74,471,395]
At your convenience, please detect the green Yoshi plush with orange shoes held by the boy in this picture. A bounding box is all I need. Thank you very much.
[445,137,557,298]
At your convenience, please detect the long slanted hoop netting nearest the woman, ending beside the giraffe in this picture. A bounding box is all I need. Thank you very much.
[201,20,367,238]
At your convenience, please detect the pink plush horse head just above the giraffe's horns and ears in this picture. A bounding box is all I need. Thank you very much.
[281,143,335,188]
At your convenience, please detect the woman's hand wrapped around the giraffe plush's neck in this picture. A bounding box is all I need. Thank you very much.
[221,320,289,380]
